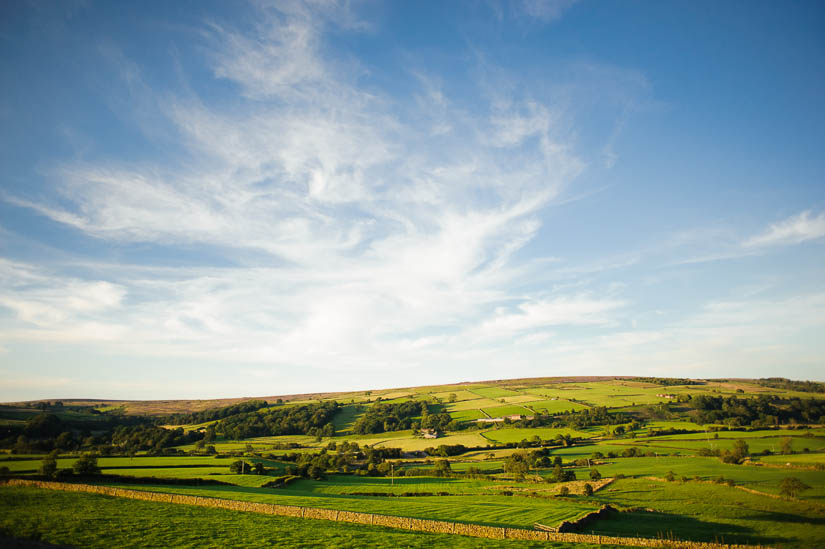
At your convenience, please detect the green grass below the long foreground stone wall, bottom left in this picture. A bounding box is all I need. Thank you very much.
[0,487,605,548]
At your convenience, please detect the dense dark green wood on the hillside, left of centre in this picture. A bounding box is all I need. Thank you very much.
[216,401,340,440]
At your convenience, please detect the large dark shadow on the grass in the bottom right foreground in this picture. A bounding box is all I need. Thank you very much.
[581,510,794,545]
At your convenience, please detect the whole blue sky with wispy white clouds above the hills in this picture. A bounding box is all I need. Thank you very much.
[0,0,825,401]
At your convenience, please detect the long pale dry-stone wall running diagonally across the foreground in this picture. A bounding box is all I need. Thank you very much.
[0,479,760,549]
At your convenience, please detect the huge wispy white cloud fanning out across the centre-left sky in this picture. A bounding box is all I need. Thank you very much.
[0,0,597,378]
